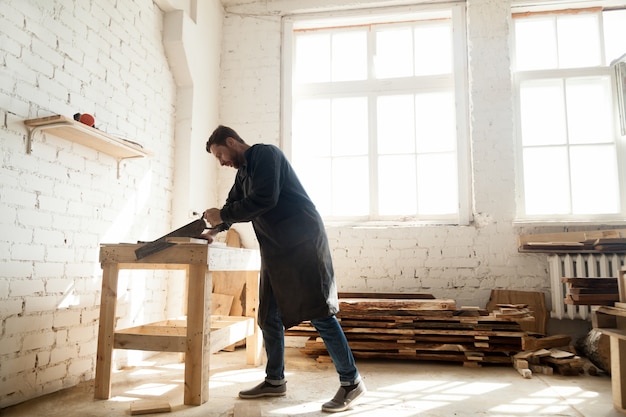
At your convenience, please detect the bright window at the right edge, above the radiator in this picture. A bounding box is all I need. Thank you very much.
[514,9,626,220]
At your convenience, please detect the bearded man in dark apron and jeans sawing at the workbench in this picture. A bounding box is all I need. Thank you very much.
[204,126,366,412]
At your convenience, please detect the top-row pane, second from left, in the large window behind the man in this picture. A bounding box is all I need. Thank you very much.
[332,30,367,81]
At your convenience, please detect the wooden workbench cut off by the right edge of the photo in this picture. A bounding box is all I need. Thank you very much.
[591,267,626,414]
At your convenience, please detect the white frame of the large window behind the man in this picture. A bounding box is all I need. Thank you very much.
[280,3,473,225]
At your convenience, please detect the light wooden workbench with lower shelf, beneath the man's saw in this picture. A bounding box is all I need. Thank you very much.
[94,243,262,405]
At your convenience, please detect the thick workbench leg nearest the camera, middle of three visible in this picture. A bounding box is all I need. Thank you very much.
[184,264,212,405]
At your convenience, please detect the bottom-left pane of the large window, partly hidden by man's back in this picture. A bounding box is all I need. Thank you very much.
[296,158,333,216]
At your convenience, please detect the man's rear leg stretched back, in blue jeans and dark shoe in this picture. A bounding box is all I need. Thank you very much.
[311,315,366,412]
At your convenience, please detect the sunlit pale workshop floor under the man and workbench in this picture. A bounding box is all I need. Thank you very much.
[0,348,624,417]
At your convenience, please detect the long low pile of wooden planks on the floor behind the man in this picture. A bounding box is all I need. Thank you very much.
[286,294,534,366]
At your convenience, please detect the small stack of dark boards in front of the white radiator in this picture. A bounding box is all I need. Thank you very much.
[561,278,619,306]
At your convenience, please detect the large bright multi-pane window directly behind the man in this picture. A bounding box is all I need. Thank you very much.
[283,5,470,224]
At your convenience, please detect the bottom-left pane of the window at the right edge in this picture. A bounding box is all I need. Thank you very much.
[523,147,570,215]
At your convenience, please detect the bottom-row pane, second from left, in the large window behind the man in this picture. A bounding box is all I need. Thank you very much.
[332,157,370,216]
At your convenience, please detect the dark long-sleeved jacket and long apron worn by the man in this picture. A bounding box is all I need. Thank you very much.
[220,145,339,328]
